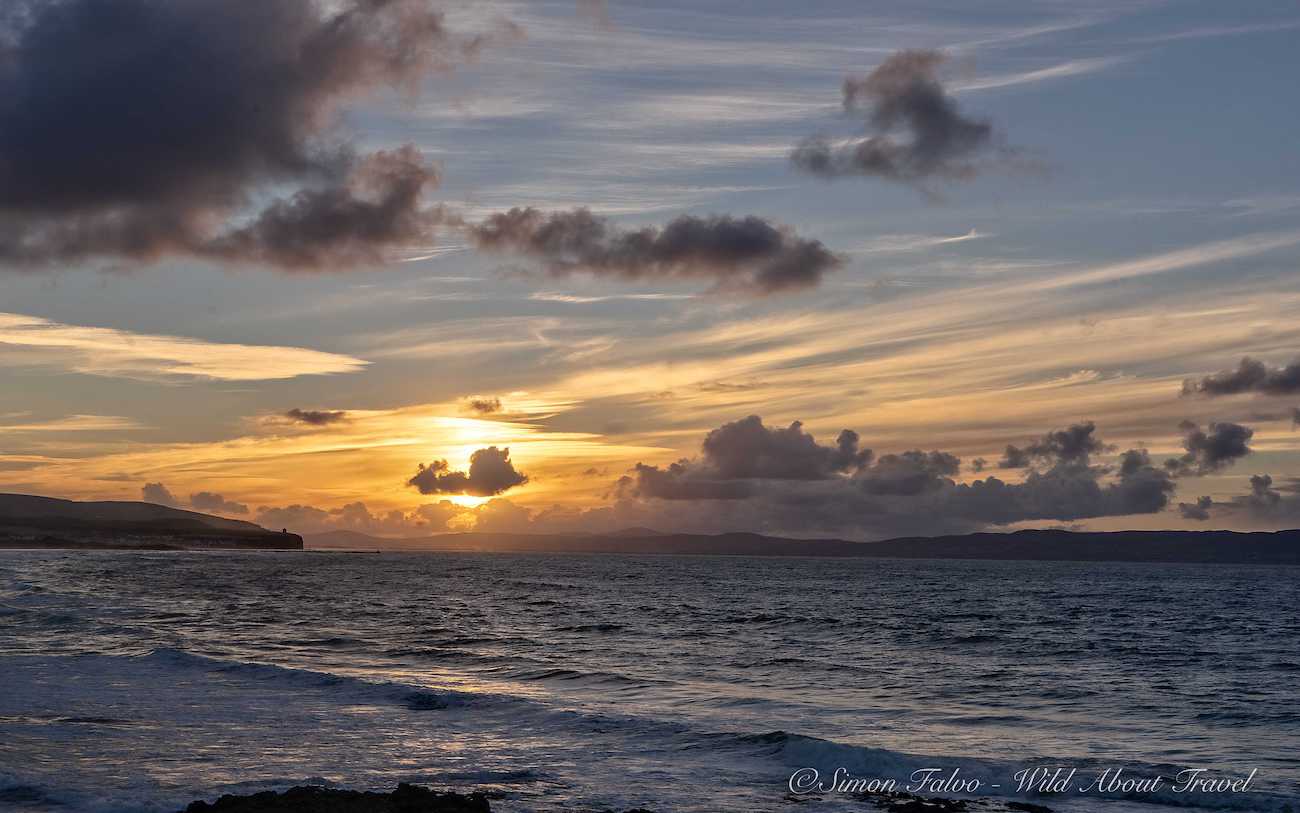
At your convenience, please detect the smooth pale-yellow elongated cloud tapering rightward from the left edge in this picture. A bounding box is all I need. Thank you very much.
[0,313,368,381]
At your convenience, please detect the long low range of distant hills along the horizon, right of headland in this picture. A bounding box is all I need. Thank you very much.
[306,531,1300,565]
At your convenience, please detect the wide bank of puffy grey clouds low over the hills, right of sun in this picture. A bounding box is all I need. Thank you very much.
[614,418,1174,539]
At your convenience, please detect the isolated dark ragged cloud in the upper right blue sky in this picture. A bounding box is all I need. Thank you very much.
[790,51,995,183]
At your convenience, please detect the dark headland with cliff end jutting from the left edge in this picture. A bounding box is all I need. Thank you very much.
[0,494,303,549]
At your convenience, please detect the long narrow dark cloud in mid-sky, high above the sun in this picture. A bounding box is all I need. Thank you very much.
[468,208,842,295]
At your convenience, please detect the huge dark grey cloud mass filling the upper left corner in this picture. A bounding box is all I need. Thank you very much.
[0,0,501,269]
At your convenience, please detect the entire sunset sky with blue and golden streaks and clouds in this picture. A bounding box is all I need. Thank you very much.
[0,0,1300,540]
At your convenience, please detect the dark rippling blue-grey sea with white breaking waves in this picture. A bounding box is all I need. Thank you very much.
[0,552,1300,813]
